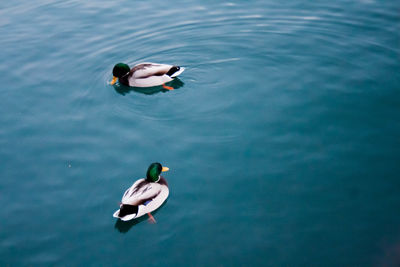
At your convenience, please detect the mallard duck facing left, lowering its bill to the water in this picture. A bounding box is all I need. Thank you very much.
[110,62,185,90]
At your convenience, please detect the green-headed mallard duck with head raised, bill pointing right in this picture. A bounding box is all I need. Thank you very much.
[113,162,169,223]
